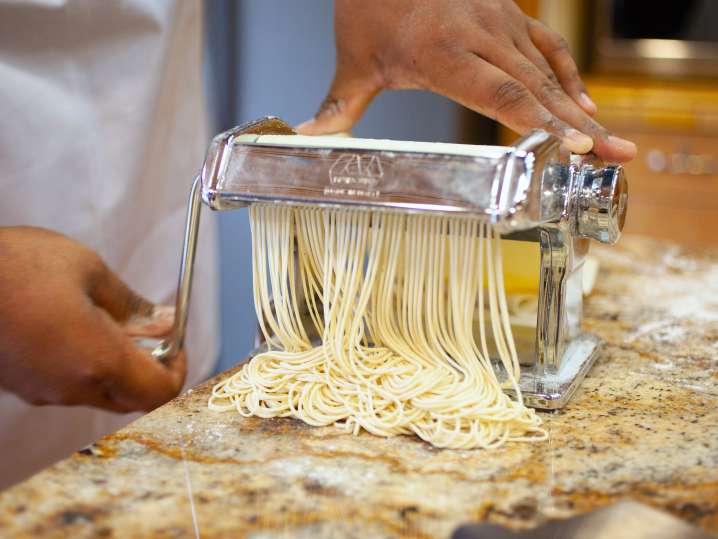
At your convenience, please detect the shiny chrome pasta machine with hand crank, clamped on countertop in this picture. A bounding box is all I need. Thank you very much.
[153,117,627,409]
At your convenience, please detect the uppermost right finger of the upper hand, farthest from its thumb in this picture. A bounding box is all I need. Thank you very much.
[528,20,597,114]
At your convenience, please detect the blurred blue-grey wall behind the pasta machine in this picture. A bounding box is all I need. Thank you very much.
[206,0,460,370]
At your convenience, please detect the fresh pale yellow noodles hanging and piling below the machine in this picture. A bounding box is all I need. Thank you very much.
[209,205,546,449]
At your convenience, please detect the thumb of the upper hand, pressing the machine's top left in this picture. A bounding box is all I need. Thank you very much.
[296,71,380,135]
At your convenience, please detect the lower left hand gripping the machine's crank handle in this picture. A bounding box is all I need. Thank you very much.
[0,227,186,412]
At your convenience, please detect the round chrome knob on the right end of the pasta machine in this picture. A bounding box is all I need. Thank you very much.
[576,165,628,244]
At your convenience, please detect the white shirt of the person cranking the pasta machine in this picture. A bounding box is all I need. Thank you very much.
[0,0,218,488]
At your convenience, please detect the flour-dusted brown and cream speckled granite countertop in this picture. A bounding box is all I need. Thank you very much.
[0,238,718,538]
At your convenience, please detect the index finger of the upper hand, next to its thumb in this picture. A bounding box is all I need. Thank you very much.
[431,53,593,153]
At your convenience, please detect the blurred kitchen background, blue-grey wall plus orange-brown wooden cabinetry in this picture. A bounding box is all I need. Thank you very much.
[205,0,718,370]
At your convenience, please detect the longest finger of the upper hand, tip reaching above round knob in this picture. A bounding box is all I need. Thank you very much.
[496,50,636,161]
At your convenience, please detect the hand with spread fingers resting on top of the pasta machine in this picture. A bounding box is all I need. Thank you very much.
[298,0,636,162]
